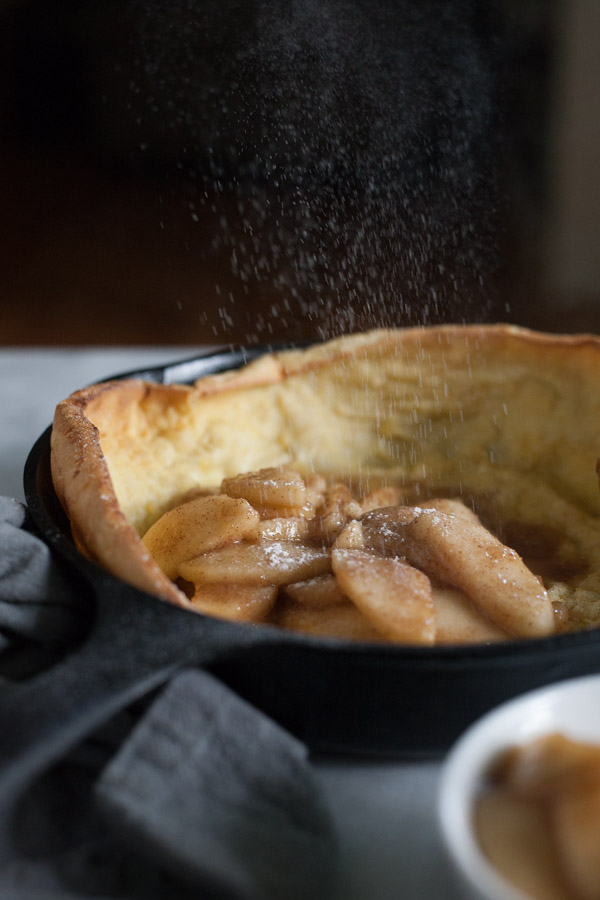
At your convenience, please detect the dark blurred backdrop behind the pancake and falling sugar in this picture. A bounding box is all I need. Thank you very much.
[0,0,600,345]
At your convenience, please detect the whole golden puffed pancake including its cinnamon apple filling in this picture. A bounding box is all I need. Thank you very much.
[51,325,600,645]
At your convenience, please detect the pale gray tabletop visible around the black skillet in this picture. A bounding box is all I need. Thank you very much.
[0,346,461,900]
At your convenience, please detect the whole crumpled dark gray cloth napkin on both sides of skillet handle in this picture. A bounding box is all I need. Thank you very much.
[0,498,336,900]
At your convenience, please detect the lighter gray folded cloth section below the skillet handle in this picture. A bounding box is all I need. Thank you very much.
[95,670,332,900]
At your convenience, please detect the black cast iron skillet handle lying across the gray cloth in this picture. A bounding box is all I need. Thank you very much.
[0,581,264,855]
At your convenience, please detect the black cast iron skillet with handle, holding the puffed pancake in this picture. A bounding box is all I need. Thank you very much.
[0,348,600,816]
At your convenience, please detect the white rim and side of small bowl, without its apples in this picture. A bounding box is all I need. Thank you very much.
[439,675,600,900]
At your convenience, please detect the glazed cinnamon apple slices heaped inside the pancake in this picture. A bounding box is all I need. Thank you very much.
[144,466,563,644]
